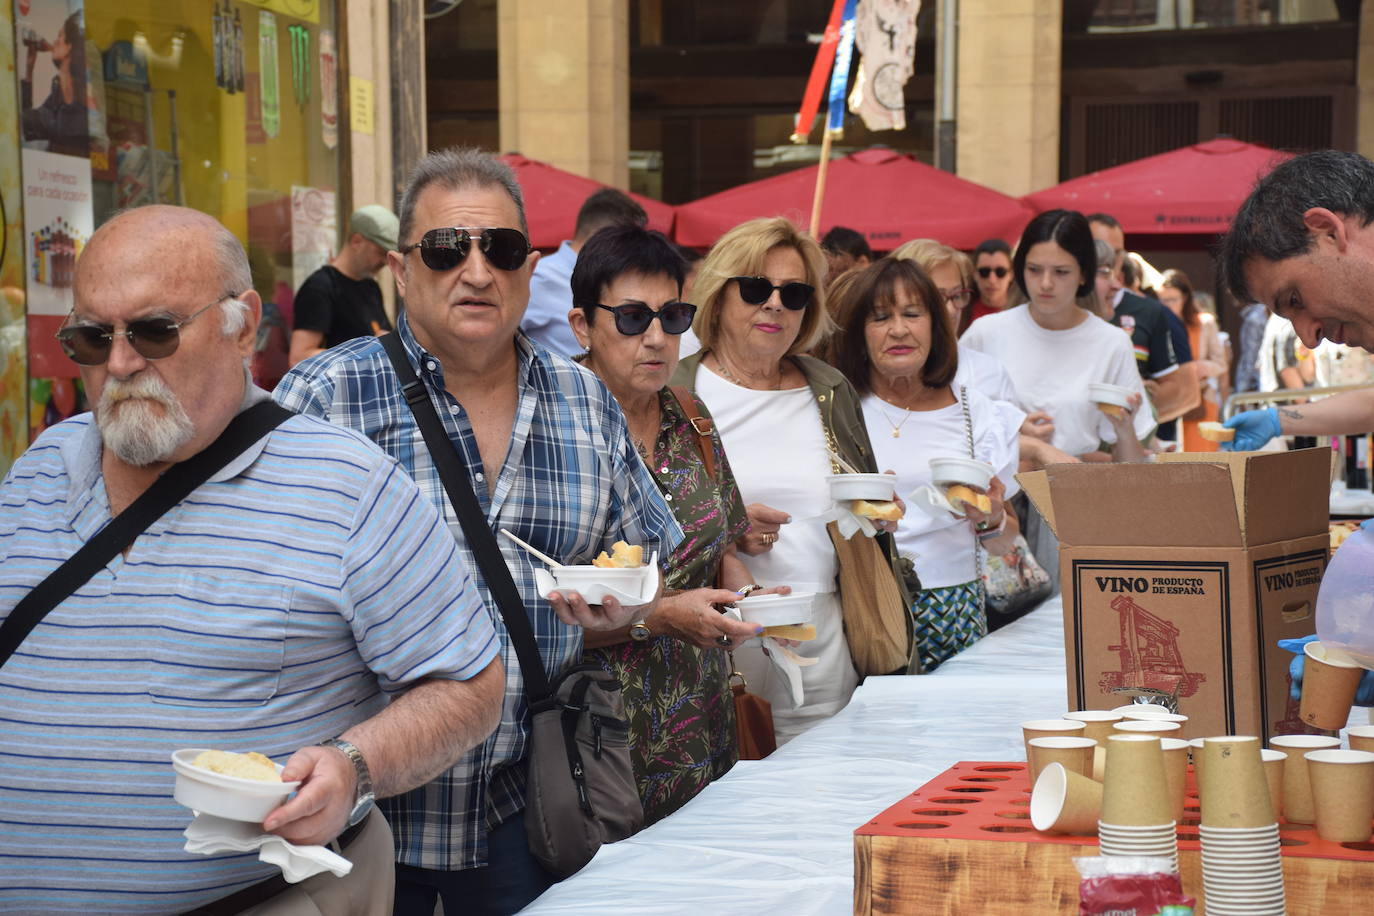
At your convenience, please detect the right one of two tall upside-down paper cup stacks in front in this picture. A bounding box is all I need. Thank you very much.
[1198,735,1286,916]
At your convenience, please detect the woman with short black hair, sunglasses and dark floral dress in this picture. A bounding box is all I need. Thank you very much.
[567,227,757,823]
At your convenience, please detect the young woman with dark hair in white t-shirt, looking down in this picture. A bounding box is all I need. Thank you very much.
[960,210,1154,461]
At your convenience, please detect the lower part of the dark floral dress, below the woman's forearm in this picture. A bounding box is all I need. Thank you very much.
[585,636,738,825]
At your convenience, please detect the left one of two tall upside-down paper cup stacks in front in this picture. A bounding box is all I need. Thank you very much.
[1098,735,1179,871]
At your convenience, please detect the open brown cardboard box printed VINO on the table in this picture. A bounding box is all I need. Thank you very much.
[1017,449,1331,740]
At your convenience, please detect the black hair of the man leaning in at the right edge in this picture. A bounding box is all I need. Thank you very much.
[1217,150,1374,302]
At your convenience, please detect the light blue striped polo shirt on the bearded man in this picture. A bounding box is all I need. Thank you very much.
[0,403,499,913]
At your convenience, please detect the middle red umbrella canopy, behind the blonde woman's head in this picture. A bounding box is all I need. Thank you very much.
[676,148,1032,251]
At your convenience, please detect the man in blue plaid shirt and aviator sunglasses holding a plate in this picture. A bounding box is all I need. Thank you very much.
[275,150,682,916]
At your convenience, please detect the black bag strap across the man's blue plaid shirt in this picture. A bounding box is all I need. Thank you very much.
[378,332,550,697]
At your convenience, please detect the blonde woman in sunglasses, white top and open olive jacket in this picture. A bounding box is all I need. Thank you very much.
[673,218,900,743]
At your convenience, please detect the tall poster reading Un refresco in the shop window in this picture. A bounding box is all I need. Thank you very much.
[14,0,91,434]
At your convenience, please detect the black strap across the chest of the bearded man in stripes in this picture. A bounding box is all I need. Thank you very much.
[0,401,293,667]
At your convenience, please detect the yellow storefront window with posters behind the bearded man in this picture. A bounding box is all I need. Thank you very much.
[5,0,341,472]
